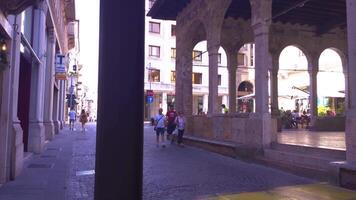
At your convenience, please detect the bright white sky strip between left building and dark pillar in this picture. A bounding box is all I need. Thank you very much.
[75,0,99,101]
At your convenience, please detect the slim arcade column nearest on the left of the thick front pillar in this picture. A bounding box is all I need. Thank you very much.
[227,51,238,114]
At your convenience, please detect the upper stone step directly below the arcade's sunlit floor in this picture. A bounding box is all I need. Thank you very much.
[271,143,346,161]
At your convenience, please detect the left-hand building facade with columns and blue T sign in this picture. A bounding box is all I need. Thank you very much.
[0,0,77,184]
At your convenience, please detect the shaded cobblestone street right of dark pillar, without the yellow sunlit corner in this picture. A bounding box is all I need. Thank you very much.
[143,126,312,200]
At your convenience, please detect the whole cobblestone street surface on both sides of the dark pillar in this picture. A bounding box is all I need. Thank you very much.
[0,124,356,200]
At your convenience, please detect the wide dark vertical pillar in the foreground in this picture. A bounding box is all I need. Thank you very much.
[94,0,145,200]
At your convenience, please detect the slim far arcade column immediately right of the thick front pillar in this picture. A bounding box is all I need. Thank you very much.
[270,56,279,117]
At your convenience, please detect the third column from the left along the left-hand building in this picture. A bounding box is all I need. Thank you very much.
[43,28,56,140]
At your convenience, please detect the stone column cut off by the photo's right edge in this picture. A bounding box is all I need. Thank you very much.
[345,0,356,162]
